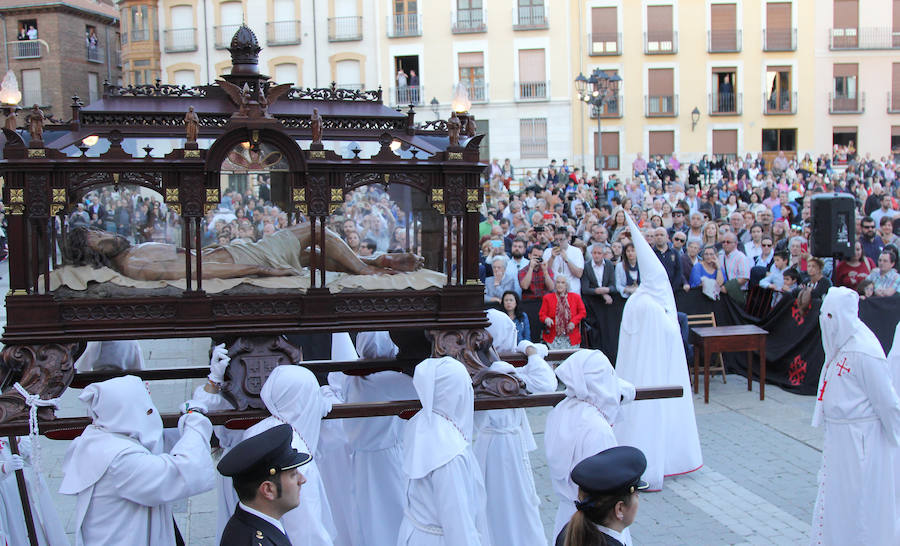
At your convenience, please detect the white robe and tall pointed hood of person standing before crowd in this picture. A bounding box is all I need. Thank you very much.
[615,210,703,491]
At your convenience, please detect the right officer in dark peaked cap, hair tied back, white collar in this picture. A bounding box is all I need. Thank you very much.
[556,446,647,546]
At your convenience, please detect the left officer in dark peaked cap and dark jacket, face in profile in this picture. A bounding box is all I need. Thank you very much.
[218,425,312,546]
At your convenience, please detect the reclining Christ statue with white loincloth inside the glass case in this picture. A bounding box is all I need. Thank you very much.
[63,222,424,281]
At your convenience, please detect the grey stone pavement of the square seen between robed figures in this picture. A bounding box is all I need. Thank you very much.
[0,264,822,546]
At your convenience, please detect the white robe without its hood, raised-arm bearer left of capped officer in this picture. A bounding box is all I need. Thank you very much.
[60,413,215,546]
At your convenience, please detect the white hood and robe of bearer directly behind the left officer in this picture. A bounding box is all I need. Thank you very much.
[244,364,337,546]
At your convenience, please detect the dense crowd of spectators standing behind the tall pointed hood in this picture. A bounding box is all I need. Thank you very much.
[479,149,900,347]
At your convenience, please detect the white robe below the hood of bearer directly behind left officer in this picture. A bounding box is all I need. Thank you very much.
[244,417,335,546]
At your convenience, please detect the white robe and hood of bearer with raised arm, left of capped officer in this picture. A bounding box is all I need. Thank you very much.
[59,375,215,546]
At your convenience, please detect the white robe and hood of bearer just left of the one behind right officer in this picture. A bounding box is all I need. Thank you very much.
[473,309,557,546]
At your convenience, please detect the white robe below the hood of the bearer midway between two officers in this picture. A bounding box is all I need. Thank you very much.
[397,447,488,546]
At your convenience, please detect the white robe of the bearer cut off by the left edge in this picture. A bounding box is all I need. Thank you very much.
[0,436,69,546]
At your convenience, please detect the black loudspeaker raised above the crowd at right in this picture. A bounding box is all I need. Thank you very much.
[809,193,856,258]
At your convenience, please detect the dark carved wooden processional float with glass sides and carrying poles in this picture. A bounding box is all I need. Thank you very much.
[0,25,682,537]
